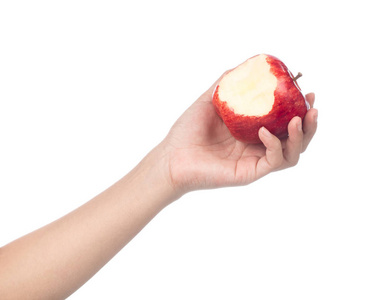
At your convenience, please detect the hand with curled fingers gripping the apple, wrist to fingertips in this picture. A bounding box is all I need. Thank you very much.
[163,76,318,194]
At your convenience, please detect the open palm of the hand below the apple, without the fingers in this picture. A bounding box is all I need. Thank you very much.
[169,98,265,188]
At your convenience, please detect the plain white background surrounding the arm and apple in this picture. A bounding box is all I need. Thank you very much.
[0,0,380,300]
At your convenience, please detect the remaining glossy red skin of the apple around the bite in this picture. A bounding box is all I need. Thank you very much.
[212,54,310,144]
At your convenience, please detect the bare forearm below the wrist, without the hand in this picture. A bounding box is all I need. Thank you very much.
[0,144,175,299]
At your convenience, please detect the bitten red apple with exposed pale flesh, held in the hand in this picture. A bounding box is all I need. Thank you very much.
[212,54,310,144]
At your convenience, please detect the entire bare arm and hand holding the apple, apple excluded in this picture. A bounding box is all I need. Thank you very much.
[0,79,317,299]
